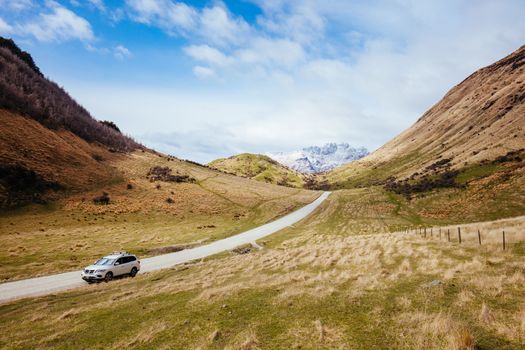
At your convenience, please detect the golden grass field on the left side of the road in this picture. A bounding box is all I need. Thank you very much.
[0,152,318,281]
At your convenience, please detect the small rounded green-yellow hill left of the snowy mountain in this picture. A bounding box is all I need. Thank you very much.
[208,153,311,187]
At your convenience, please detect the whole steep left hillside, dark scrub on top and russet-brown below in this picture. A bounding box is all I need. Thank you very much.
[0,37,141,209]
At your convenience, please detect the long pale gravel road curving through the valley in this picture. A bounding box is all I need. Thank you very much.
[0,192,330,302]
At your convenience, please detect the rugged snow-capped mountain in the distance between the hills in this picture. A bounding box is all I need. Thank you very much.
[266,143,368,173]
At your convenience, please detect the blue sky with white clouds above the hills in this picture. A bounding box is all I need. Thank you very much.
[0,0,525,163]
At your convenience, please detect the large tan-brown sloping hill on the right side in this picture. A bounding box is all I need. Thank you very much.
[327,46,525,188]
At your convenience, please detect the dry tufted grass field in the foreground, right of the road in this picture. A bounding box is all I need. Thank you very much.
[0,203,525,349]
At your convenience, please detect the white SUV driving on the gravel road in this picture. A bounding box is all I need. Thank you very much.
[80,252,140,282]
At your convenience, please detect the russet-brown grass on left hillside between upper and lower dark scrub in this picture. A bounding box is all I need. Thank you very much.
[0,109,118,203]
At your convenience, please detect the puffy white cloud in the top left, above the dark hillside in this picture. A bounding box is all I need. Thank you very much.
[19,1,95,42]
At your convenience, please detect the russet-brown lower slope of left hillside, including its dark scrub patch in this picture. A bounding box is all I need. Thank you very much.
[0,109,120,208]
